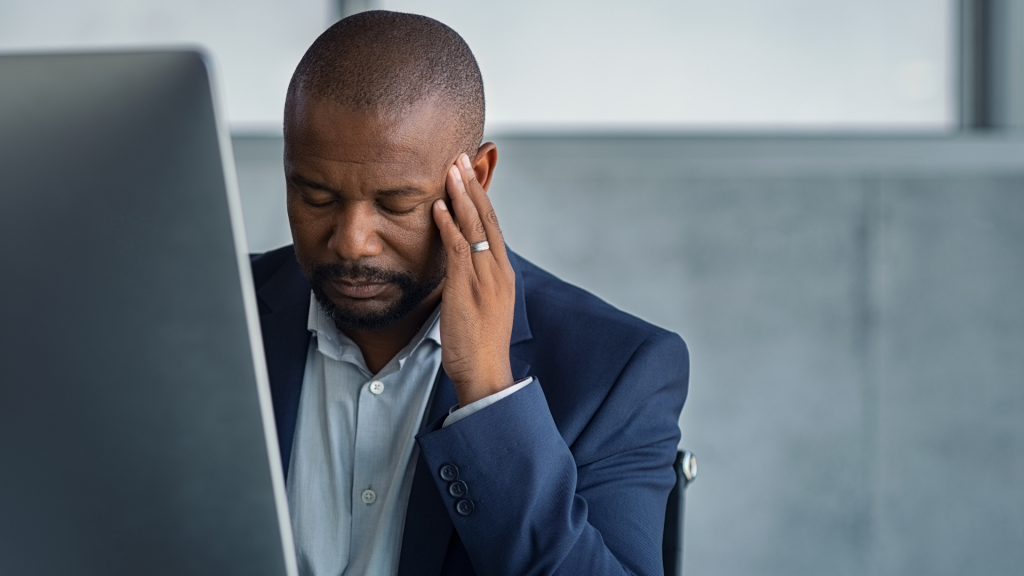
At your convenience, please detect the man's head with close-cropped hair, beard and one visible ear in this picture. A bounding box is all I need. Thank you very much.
[285,11,497,330]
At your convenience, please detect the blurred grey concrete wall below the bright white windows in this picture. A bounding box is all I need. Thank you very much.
[234,137,1024,576]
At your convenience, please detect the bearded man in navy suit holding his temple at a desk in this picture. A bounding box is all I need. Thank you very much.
[253,11,689,576]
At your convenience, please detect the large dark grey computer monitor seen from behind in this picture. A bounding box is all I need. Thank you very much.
[0,50,297,576]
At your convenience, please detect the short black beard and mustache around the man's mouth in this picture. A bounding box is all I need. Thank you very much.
[309,251,444,332]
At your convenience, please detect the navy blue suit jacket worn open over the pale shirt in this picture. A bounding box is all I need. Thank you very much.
[252,246,689,576]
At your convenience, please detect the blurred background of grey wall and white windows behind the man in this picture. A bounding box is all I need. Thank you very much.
[0,0,1024,576]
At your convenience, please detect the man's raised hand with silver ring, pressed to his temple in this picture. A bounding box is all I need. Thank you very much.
[433,154,515,406]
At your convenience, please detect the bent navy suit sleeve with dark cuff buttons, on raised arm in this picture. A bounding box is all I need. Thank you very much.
[418,333,689,576]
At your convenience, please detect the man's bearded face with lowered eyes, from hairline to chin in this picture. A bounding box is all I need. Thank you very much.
[285,94,456,330]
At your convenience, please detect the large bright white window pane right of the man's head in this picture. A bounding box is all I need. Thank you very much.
[377,0,954,131]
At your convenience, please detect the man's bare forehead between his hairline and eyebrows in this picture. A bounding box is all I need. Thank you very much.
[285,95,457,182]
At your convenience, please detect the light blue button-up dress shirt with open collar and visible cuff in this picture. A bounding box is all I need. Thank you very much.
[287,297,531,576]
